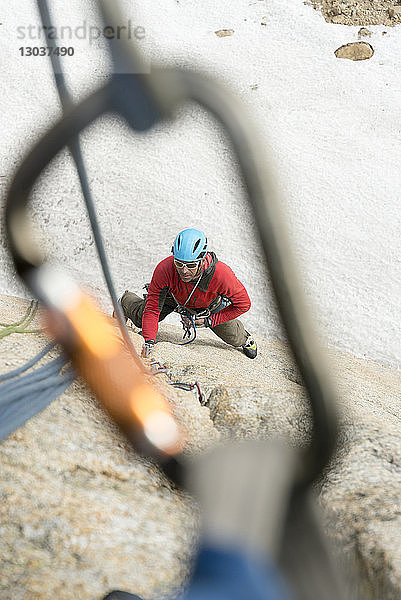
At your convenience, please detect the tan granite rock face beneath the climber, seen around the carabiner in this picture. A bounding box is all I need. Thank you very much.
[0,296,401,600]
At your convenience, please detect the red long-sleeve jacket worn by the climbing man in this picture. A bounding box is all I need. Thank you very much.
[142,252,251,340]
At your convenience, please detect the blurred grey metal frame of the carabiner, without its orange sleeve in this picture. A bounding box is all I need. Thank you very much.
[6,0,337,489]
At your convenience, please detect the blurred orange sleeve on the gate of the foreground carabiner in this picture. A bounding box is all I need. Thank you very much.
[45,291,185,459]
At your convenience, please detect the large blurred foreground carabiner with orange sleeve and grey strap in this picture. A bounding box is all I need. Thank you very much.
[5,0,343,600]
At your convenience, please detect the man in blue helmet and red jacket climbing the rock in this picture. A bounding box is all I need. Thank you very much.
[119,229,257,358]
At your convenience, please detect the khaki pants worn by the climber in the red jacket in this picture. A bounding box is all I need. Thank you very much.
[121,292,248,347]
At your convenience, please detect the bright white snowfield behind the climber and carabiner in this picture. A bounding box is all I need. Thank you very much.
[0,0,401,376]
